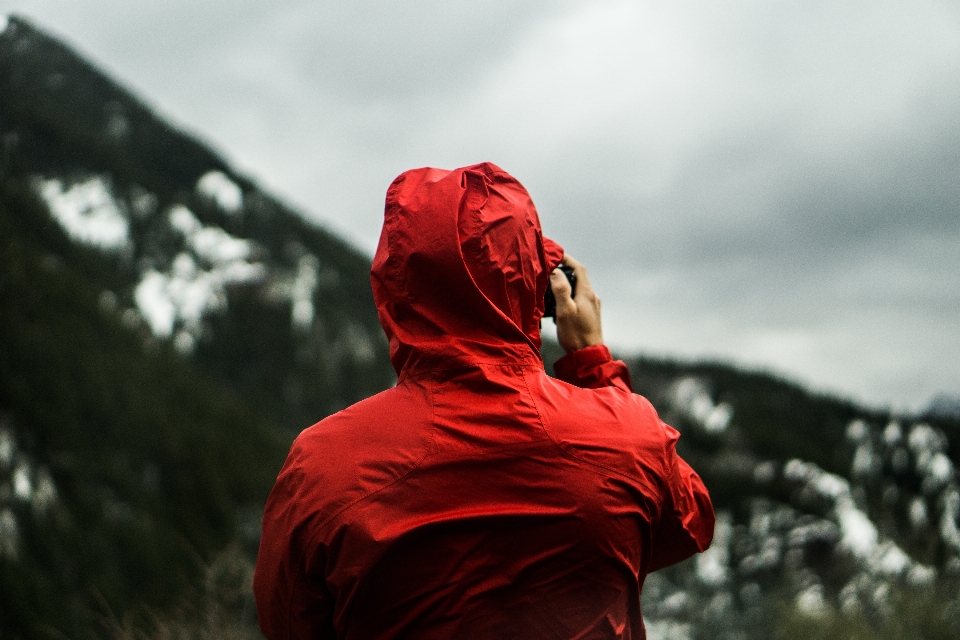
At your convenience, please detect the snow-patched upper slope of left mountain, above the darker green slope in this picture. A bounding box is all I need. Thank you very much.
[0,18,392,431]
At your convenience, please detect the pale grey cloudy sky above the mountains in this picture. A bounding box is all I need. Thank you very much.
[0,0,960,409]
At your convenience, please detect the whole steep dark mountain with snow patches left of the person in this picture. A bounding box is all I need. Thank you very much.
[0,17,394,638]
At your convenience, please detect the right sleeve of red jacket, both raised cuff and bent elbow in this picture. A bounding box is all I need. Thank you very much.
[553,344,715,571]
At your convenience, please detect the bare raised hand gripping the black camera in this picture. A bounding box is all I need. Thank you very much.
[549,256,603,353]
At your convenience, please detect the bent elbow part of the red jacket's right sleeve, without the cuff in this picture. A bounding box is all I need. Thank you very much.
[650,422,715,571]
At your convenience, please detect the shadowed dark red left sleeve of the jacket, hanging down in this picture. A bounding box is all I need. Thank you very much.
[253,444,336,640]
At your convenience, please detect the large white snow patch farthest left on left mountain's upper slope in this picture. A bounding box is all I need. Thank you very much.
[34,176,130,250]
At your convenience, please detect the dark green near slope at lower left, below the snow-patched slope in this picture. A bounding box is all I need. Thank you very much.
[0,186,288,637]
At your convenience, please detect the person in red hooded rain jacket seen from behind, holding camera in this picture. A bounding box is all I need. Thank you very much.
[254,163,714,640]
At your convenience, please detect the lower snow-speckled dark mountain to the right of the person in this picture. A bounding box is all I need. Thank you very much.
[630,358,960,639]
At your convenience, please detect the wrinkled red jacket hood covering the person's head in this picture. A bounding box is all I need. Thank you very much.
[370,163,563,377]
